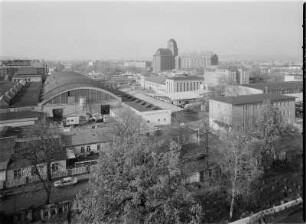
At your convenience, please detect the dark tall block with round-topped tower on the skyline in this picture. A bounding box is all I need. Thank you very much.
[152,39,178,72]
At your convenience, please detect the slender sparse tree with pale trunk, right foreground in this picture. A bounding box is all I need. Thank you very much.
[211,131,262,220]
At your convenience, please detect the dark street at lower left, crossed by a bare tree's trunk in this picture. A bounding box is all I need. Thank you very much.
[0,178,88,212]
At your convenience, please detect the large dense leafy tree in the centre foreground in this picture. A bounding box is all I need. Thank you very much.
[75,135,202,223]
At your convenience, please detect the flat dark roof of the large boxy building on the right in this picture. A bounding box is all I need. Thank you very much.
[212,94,295,105]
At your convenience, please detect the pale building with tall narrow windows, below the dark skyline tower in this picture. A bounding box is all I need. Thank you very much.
[166,76,203,93]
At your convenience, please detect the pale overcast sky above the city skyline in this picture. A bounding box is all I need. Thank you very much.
[0,1,303,59]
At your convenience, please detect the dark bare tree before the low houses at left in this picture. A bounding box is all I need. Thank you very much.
[16,118,65,204]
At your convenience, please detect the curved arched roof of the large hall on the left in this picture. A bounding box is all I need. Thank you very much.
[41,71,121,104]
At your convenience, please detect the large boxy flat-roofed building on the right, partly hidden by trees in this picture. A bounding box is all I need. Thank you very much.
[209,94,295,131]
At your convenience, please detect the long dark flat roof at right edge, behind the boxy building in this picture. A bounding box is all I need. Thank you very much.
[242,81,303,91]
